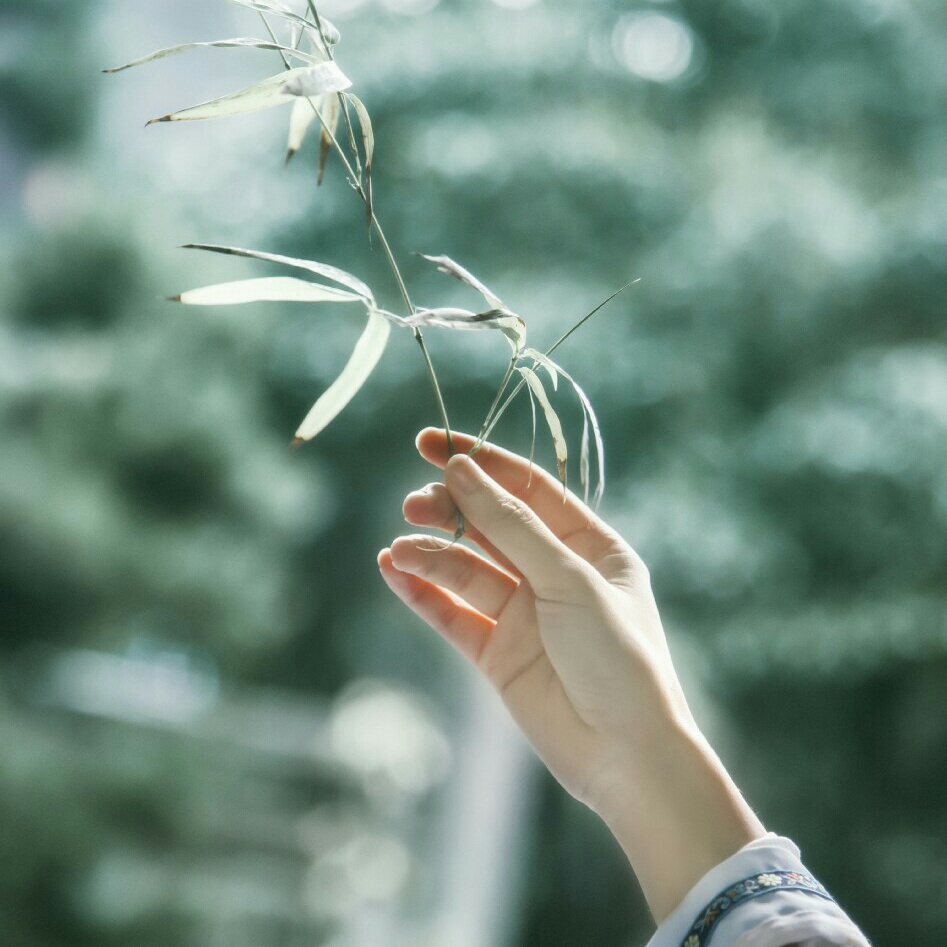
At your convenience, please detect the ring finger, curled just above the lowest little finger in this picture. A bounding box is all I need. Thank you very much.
[391,536,519,621]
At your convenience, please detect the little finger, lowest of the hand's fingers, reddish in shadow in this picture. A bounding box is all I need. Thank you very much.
[378,549,494,664]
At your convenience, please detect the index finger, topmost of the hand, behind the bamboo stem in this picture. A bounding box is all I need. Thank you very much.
[415,427,624,555]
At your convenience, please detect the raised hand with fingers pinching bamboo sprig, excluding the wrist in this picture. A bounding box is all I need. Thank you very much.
[378,428,690,809]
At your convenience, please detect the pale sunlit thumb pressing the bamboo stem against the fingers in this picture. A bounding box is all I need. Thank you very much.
[444,454,591,600]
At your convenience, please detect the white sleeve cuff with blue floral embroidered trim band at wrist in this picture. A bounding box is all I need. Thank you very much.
[646,832,871,947]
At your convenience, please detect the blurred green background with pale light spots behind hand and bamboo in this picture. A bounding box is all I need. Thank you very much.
[0,0,947,947]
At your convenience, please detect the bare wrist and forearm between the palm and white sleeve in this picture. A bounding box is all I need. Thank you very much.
[595,717,766,924]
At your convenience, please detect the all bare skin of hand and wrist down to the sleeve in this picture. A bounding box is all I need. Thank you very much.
[378,428,766,923]
